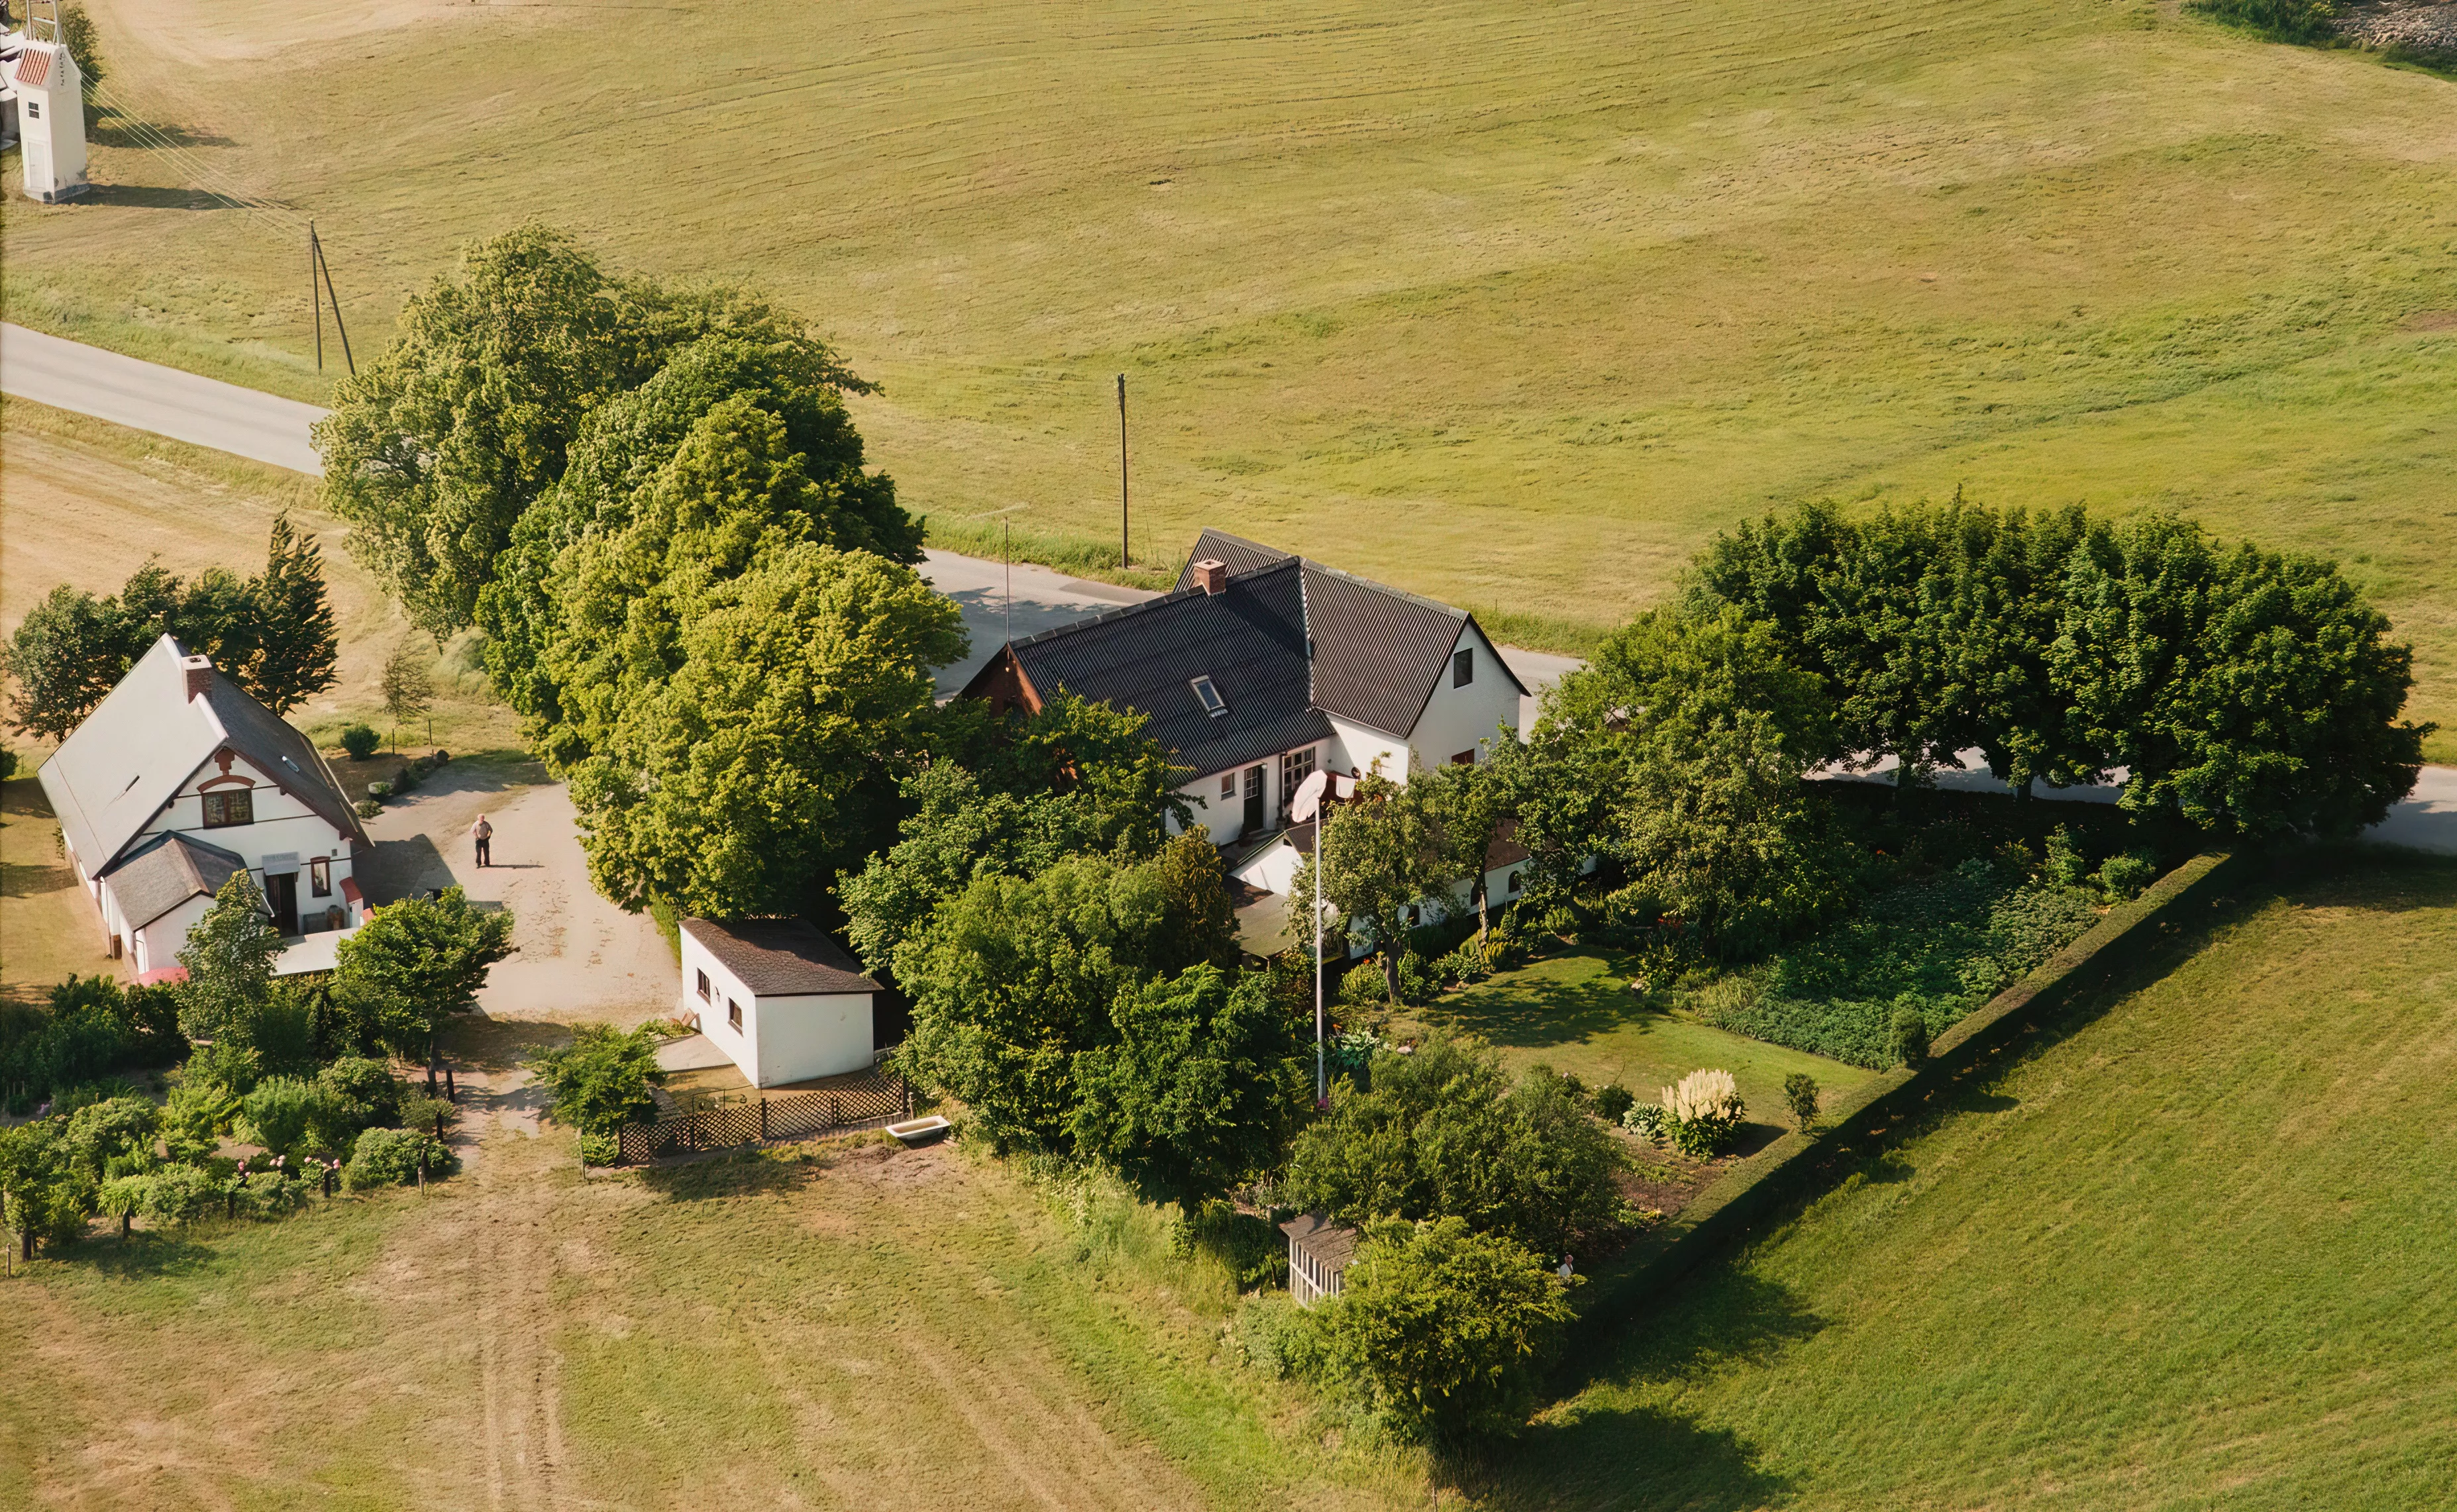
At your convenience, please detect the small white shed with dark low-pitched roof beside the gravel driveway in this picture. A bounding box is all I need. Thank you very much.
[680,918,880,1087]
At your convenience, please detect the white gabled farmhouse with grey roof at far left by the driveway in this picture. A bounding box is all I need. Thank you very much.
[42,636,366,980]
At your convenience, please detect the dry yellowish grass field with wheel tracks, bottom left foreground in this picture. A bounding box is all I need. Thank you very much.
[0,1070,1428,1512]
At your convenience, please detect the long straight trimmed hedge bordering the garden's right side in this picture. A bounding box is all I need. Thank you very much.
[1580,852,2236,1338]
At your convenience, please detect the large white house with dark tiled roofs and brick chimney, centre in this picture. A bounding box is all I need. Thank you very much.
[963,530,1528,952]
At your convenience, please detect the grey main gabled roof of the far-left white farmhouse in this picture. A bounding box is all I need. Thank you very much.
[42,636,366,876]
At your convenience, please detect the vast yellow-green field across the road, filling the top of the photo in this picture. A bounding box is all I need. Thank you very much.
[5,0,2457,758]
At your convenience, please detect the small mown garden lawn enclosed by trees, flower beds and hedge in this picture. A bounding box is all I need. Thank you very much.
[1413,952,1872,1127]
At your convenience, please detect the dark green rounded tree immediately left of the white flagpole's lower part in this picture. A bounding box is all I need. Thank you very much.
[1074,962,1304,1213]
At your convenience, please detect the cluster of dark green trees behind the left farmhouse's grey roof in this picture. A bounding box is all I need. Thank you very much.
[5,513,339,741]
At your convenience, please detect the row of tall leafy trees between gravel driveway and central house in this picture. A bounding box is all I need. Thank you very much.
[317,226,966,915]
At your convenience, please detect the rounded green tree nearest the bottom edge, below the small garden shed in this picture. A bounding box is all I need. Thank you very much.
[1322,1217,1573,1443]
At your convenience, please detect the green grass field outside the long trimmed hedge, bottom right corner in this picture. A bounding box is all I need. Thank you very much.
[1489,852,2457,1509]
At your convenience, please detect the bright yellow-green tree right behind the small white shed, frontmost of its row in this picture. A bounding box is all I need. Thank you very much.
[572,540,963,918]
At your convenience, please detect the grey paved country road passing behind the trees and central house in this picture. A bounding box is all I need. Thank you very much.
[0,324,2457,854]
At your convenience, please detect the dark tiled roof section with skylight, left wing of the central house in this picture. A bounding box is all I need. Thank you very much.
[1012,557,1332,773]
